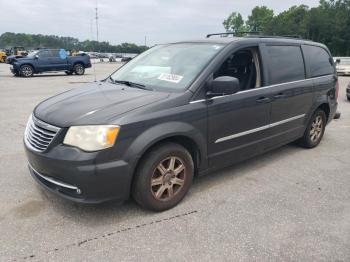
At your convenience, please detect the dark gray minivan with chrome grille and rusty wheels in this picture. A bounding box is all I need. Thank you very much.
[24,36,338,211]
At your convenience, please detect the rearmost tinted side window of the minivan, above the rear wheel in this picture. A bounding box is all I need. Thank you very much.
[303,45,334,77]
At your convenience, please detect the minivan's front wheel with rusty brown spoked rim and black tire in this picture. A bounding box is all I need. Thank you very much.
[132,143,194,211]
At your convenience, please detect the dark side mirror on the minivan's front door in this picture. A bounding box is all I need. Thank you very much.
[207,76,240,97]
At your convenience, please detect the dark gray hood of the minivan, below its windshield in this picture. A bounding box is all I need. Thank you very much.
[34,82,169,127]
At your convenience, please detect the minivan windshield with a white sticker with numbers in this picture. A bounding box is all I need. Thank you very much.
[110,43,223,91]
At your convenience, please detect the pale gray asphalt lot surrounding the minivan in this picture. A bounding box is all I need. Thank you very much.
[0,64,350,261]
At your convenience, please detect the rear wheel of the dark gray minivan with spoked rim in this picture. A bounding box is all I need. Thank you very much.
[299,109,327,148]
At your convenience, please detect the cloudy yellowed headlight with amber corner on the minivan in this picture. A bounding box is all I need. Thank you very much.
[63,125,120,151]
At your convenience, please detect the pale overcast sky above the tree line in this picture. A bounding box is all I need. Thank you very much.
[0,0,319,45]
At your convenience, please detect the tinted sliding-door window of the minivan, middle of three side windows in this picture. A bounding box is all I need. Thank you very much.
[266,46,305,85]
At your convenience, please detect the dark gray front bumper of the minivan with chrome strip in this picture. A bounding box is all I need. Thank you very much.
[25,145,132,203]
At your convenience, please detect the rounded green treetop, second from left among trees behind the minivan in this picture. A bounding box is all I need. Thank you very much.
[246,6,274,32]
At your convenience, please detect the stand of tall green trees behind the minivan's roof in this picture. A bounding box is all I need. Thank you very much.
[223,0,350,56]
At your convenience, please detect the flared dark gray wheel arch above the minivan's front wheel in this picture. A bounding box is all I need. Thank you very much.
[125,121,207,171]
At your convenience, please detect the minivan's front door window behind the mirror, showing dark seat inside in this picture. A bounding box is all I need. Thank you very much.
[214,47,261,91]
